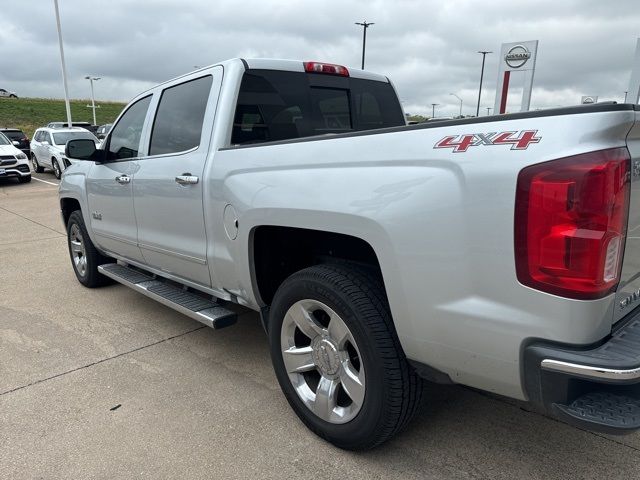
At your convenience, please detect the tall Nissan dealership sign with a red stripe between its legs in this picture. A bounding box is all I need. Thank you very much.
[493,40,538,113]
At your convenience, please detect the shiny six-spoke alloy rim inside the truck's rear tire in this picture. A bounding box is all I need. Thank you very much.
[280,299,365,424]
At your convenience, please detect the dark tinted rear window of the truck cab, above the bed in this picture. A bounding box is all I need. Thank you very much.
[231,70,405,145]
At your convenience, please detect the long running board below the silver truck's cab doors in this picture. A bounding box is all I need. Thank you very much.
[98,263,238,329]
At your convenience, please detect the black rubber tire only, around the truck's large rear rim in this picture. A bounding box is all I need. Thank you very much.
[269,265,423,450]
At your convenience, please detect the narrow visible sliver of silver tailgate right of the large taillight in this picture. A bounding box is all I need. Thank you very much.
[613,112,640,323]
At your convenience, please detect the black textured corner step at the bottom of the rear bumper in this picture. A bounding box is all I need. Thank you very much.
[553,392,640,434]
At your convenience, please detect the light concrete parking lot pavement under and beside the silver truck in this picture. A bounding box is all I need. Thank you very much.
[0,173,640,479]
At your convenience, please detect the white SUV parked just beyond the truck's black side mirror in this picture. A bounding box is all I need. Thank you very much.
[31,127,100,178]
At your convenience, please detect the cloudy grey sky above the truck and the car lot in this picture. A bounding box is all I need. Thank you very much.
[0,0,640,116]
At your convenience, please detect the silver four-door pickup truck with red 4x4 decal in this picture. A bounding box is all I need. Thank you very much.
[60,59,640,449]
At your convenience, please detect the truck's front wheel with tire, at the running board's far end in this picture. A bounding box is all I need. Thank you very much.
[67,210,113,288]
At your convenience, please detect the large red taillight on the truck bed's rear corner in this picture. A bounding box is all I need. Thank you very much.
[515,148,630,299]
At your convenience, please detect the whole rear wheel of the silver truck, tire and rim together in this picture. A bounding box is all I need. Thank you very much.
[269,265,422,450]
